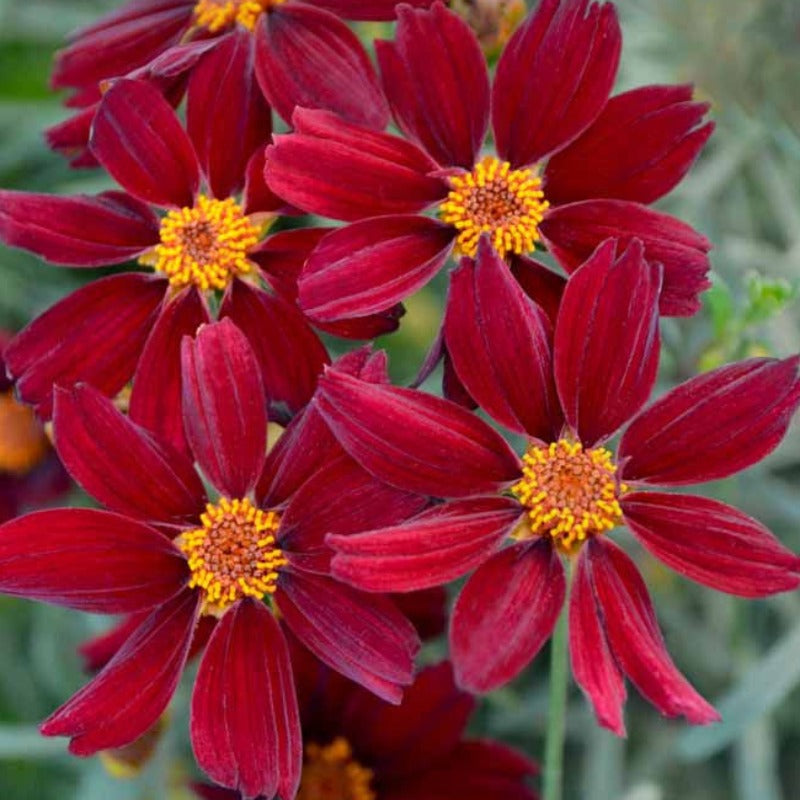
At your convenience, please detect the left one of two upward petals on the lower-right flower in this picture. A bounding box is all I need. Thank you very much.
[444,244,563,441]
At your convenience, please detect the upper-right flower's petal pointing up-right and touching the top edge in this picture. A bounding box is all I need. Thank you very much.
[492,0,622,167]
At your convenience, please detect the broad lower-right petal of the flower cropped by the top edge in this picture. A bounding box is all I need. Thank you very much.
[256,3,389,130]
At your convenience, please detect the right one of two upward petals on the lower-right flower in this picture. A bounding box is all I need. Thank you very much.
[555,240,661,447]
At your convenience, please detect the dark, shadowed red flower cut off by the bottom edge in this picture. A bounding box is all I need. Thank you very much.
[195,647,537,800]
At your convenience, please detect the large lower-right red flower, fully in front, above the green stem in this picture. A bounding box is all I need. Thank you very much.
[315,240,800,734]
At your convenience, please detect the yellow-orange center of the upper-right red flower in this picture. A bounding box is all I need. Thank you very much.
[439,156,550,257]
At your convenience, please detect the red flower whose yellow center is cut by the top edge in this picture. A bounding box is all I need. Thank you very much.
[47,0,431,166]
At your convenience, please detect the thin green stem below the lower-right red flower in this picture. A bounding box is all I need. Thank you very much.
[542,563,572,800]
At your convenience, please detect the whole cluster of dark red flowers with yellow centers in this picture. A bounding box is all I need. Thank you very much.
[0,0,800,800]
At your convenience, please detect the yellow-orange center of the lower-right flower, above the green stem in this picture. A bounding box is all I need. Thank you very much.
[511,439,628,555]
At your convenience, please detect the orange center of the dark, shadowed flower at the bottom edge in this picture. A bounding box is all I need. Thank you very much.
[297,737,377,800]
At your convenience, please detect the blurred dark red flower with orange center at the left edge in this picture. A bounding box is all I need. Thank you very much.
[0,331,70,522]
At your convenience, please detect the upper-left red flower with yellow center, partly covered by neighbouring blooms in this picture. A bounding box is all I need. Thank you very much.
[0,80,344,434]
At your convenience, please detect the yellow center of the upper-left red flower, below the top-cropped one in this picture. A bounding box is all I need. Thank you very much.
[139,195,260,291]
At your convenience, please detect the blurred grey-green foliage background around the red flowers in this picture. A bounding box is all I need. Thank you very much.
[0,0,800,800]
